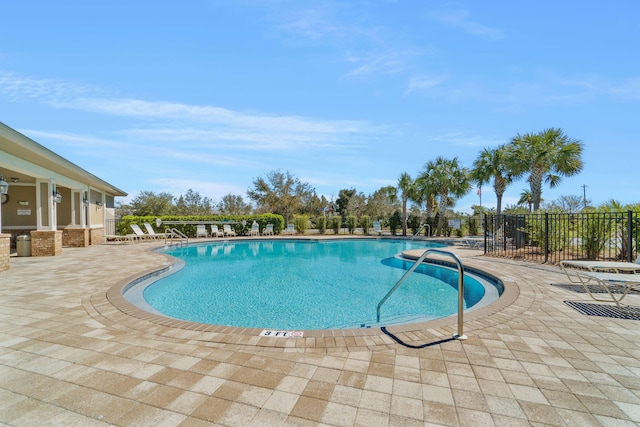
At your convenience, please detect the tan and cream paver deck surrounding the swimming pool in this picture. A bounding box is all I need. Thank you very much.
[0,242,640,427]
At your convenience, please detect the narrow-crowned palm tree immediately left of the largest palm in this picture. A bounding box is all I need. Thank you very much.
[471,145,512,215]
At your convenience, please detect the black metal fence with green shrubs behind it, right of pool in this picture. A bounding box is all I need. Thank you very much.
[484,211,640,264]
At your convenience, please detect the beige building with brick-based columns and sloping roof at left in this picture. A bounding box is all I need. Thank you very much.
[0,122,127,271]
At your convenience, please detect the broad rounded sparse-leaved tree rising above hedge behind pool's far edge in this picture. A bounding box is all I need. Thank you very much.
[247,170,315,222]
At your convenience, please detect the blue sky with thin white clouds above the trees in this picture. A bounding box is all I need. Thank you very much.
[0,0,640,211]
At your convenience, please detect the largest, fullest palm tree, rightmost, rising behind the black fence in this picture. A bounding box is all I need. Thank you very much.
[507,128,583,211]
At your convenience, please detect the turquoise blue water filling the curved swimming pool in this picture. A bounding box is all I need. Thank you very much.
[130,239,497,330]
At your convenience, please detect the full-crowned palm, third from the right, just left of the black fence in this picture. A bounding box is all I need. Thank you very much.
[419,156,471,236]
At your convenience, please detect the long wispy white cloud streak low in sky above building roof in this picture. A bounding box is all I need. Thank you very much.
[0,74,384,154]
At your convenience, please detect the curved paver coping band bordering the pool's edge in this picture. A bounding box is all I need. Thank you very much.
[96,236,531,351]
